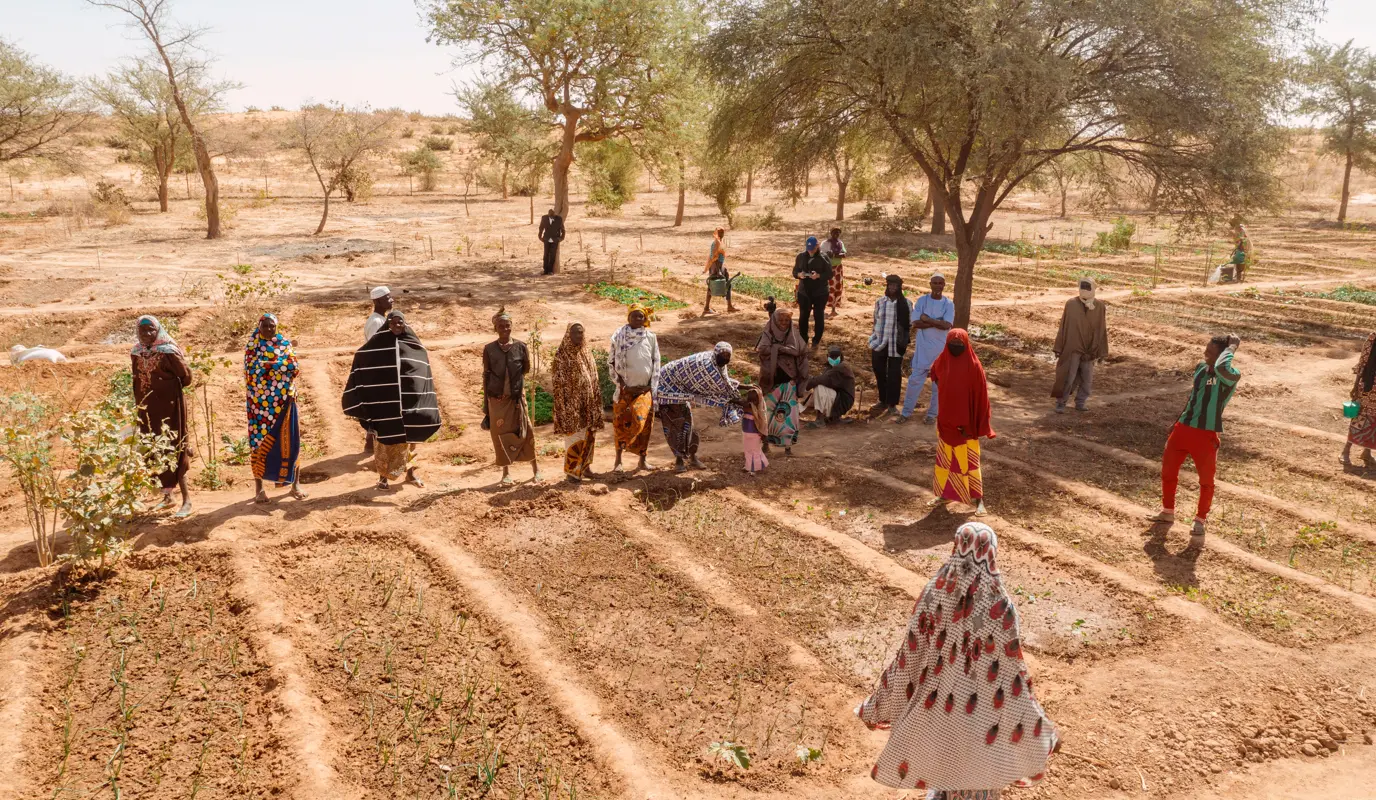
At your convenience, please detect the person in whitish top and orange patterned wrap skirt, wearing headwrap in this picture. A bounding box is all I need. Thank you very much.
[607,306,659,472]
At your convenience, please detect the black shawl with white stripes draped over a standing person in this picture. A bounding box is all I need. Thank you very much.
[344,328,439,445]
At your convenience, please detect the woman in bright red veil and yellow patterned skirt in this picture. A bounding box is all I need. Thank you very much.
[932,328,993,515]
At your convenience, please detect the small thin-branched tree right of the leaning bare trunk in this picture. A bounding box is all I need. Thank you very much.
[288,103,396,235]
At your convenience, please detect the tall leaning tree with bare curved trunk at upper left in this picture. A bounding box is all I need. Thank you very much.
[87,0,220,238]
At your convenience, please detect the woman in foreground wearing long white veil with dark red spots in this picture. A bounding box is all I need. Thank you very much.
[856,522,1060,800]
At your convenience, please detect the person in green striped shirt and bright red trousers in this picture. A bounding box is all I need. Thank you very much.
[1149,335,1243,544]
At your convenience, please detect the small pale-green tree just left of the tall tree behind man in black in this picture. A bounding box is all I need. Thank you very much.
[454,83,550,200]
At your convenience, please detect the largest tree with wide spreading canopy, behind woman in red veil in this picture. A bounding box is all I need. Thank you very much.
[707,0,1298,325]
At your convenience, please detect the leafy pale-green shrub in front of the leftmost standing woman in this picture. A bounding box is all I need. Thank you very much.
[58,398,176,570]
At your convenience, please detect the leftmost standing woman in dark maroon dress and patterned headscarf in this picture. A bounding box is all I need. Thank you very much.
[129,315,195,518]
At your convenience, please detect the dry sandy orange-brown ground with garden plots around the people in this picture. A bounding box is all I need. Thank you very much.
[0,163,1376,799]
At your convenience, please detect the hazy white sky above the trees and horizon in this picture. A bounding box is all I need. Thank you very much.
[8,0,1376,114]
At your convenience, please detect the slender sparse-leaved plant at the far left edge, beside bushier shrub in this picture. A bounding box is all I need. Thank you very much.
[0,391,58,567]
